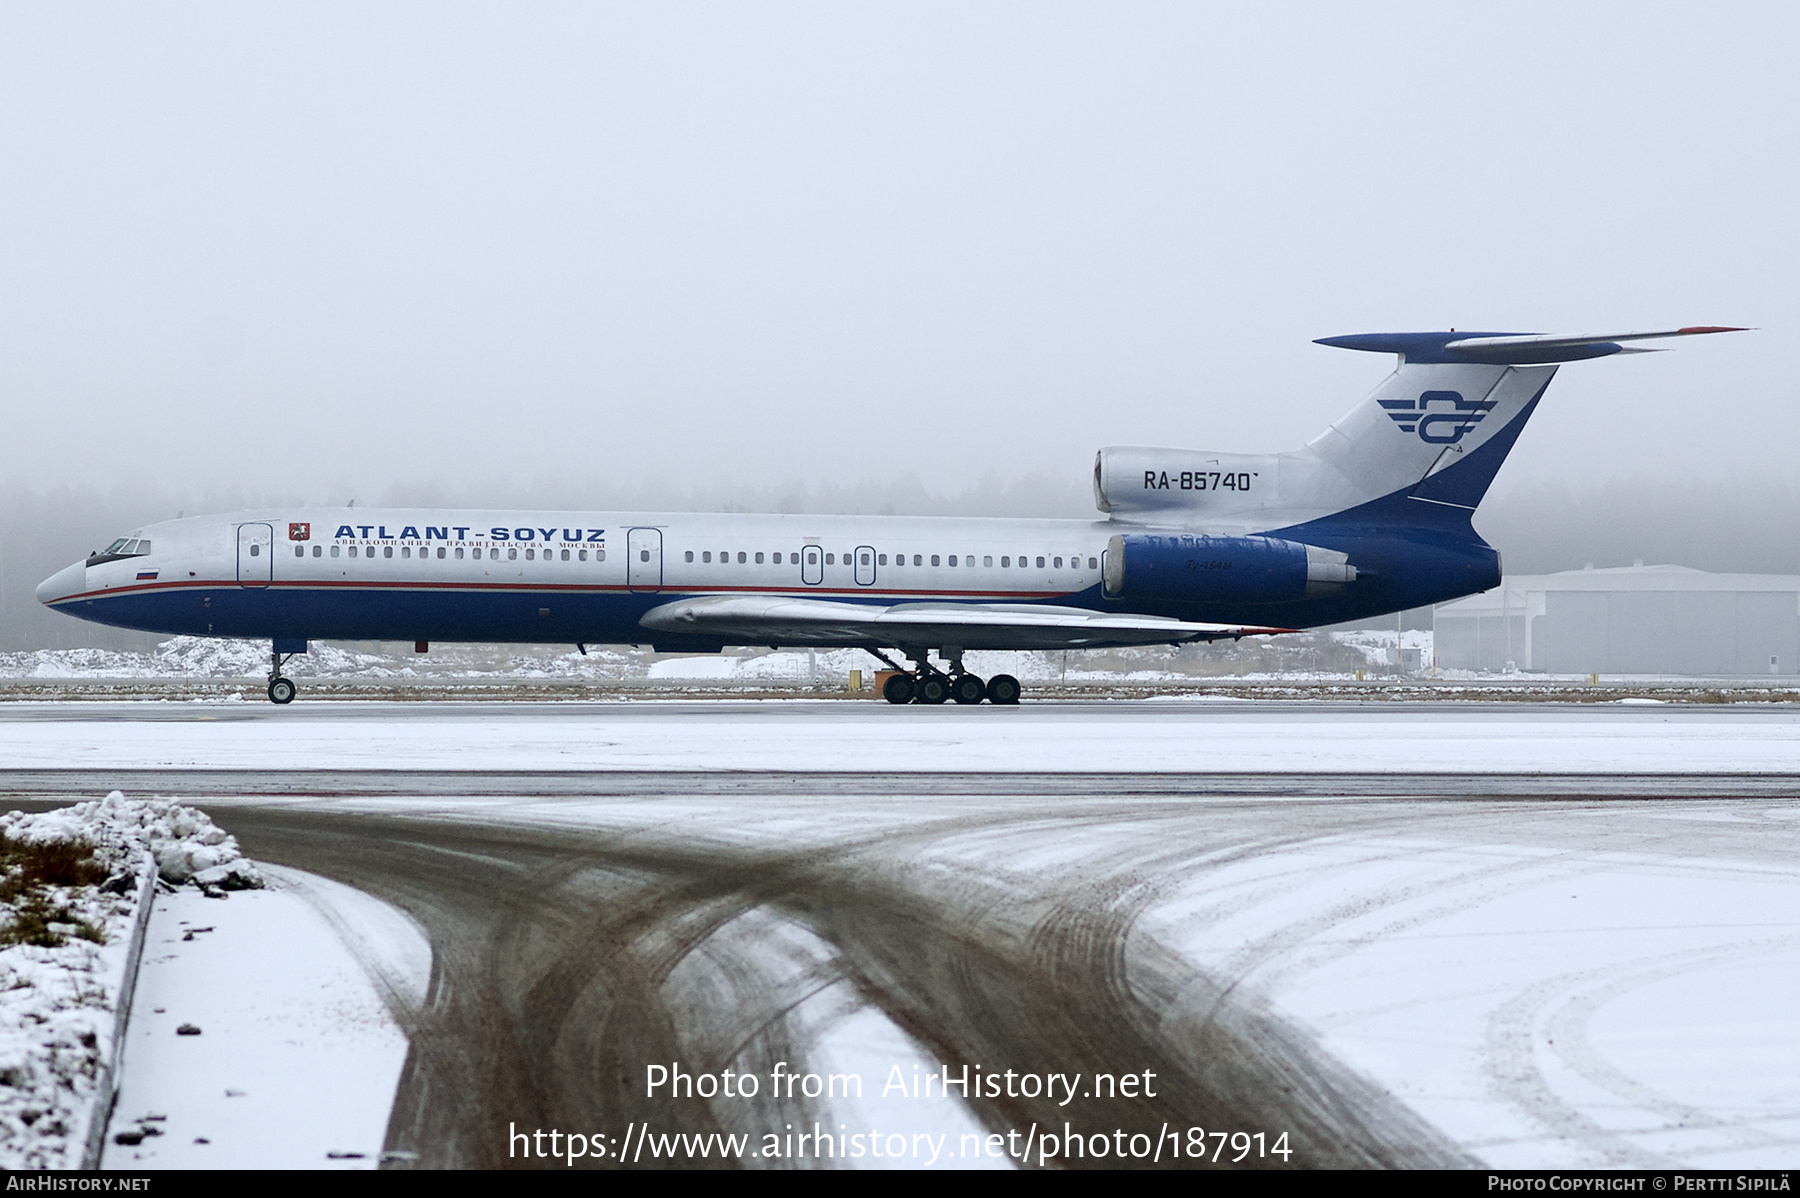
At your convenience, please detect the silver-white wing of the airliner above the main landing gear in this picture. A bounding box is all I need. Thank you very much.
[639,595,1292,649]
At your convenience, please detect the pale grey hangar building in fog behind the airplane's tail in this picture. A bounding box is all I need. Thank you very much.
[1433,565,1800,678]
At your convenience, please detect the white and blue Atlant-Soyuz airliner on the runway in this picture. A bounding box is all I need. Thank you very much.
[38,326,1742,705]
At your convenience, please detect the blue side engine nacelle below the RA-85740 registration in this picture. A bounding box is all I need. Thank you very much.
[1102,532,1355,603]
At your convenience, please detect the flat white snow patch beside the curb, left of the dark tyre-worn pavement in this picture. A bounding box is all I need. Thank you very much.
[103,867,430,1169]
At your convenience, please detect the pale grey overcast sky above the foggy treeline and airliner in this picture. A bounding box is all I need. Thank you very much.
[0,0,1800,514]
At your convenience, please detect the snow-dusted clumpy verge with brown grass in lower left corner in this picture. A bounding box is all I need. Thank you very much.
[0,791,263,1169]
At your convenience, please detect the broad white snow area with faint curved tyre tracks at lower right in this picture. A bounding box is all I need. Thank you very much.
[1147,827,1800,1169]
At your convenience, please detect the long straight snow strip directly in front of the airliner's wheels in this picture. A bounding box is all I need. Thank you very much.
[0,702,1800,773]
